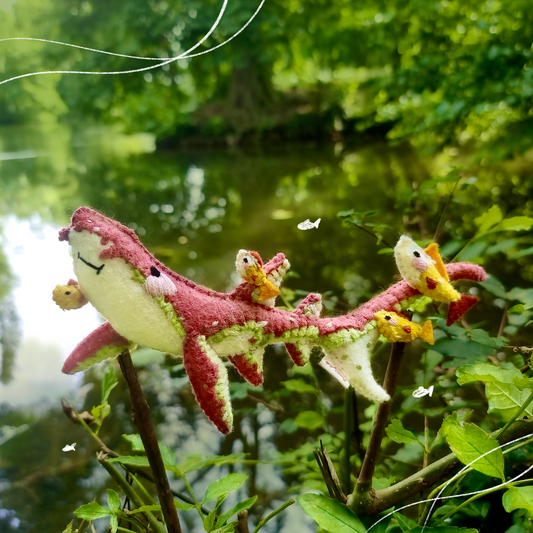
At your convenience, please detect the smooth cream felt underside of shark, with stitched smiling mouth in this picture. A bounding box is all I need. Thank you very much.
[69,231,183,355]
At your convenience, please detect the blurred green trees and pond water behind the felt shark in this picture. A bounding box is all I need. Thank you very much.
[0,0,533,533]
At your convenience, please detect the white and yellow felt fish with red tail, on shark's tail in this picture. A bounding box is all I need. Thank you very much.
[394,235,479,326]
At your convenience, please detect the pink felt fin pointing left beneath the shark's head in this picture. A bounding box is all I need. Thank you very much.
[62,322,133,374]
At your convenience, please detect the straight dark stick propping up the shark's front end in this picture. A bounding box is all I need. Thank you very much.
[118,350,182,533]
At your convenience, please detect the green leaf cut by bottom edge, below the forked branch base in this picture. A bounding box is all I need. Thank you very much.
[296,493,366,533]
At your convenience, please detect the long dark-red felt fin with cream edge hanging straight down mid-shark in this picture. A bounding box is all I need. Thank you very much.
[183,335,233,435]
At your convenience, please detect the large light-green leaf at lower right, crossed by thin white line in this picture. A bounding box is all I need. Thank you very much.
[441,413,504,479]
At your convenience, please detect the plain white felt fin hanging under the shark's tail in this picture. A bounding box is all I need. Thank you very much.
[321,328,390,402]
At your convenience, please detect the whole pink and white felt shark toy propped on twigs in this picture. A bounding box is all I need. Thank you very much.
[59,207,486,433]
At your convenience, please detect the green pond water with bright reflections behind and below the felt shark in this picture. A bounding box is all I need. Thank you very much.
[0,125,527,533]
